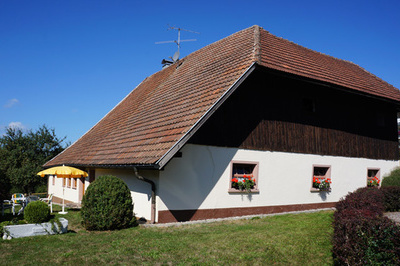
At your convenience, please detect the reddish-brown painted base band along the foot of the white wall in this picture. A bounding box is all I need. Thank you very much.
[158,202,336,223]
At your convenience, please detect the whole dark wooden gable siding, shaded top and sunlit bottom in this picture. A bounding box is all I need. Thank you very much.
[189,70,399,160]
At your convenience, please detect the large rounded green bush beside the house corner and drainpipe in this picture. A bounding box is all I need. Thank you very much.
[81,175,136,231]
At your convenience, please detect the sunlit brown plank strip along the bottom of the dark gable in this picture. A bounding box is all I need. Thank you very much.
[239,120,399,160]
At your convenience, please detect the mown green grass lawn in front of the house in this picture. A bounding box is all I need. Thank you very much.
[0,207,333,265]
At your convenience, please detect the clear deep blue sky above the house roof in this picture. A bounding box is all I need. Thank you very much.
[0,0,400,145]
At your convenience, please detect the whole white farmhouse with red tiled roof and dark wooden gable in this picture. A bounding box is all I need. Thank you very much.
[45,26,400,223]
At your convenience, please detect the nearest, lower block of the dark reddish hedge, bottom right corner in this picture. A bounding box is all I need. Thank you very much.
[333,210,400,265]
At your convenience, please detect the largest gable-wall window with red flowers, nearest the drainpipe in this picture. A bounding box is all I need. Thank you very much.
[228,161,258,193]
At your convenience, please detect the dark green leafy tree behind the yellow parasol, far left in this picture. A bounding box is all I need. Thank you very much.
[0,125,65,196]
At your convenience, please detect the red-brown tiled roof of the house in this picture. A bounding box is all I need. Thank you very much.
[45,26,400,167]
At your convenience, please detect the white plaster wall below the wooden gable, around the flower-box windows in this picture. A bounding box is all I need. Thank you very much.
[158,144,399,210]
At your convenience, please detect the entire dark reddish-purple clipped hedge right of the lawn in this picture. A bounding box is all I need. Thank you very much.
[332,188,400,265]
